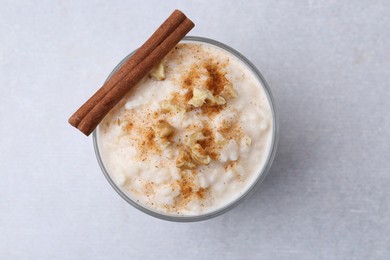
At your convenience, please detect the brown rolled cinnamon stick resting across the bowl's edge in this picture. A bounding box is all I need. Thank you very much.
[69,10,194,135]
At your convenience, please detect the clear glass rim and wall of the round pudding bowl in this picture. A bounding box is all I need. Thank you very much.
[93,36,279,222]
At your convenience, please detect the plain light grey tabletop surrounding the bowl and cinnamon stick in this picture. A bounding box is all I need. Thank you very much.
[0,0,390,259]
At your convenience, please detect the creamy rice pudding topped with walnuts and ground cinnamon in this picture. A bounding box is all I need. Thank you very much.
[97,41,274,216]
